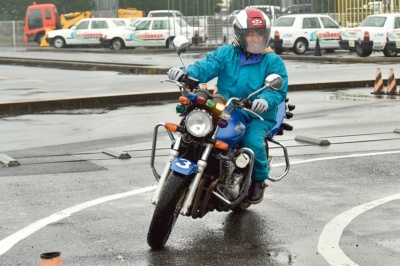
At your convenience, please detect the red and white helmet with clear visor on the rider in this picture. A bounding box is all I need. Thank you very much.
[232,8,271,54]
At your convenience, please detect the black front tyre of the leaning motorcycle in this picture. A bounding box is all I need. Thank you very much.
[147,171,190,250]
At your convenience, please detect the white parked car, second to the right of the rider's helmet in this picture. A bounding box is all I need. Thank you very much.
[339,13,400,57]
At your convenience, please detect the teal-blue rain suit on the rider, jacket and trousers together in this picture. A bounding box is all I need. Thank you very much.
[188,44,288,180]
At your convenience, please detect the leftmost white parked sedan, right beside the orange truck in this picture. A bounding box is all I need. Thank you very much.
[45,18,126,48]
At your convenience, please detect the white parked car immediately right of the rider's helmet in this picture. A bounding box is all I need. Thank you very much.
[270,14,342,55]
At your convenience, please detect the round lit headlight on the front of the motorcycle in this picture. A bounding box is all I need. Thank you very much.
[186,110,213,137]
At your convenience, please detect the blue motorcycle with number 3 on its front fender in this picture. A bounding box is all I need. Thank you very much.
[147,36,295,250]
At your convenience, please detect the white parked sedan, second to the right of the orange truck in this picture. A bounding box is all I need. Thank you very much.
[100,17,205,50]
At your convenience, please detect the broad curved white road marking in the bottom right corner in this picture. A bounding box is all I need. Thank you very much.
[318,194,400,266]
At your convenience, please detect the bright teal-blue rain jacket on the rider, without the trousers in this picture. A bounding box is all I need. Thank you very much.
[188,44,288,124]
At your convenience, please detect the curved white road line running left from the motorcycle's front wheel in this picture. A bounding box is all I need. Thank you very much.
[0,186,156,256]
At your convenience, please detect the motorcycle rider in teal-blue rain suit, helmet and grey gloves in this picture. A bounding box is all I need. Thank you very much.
[167,8,288,204]
